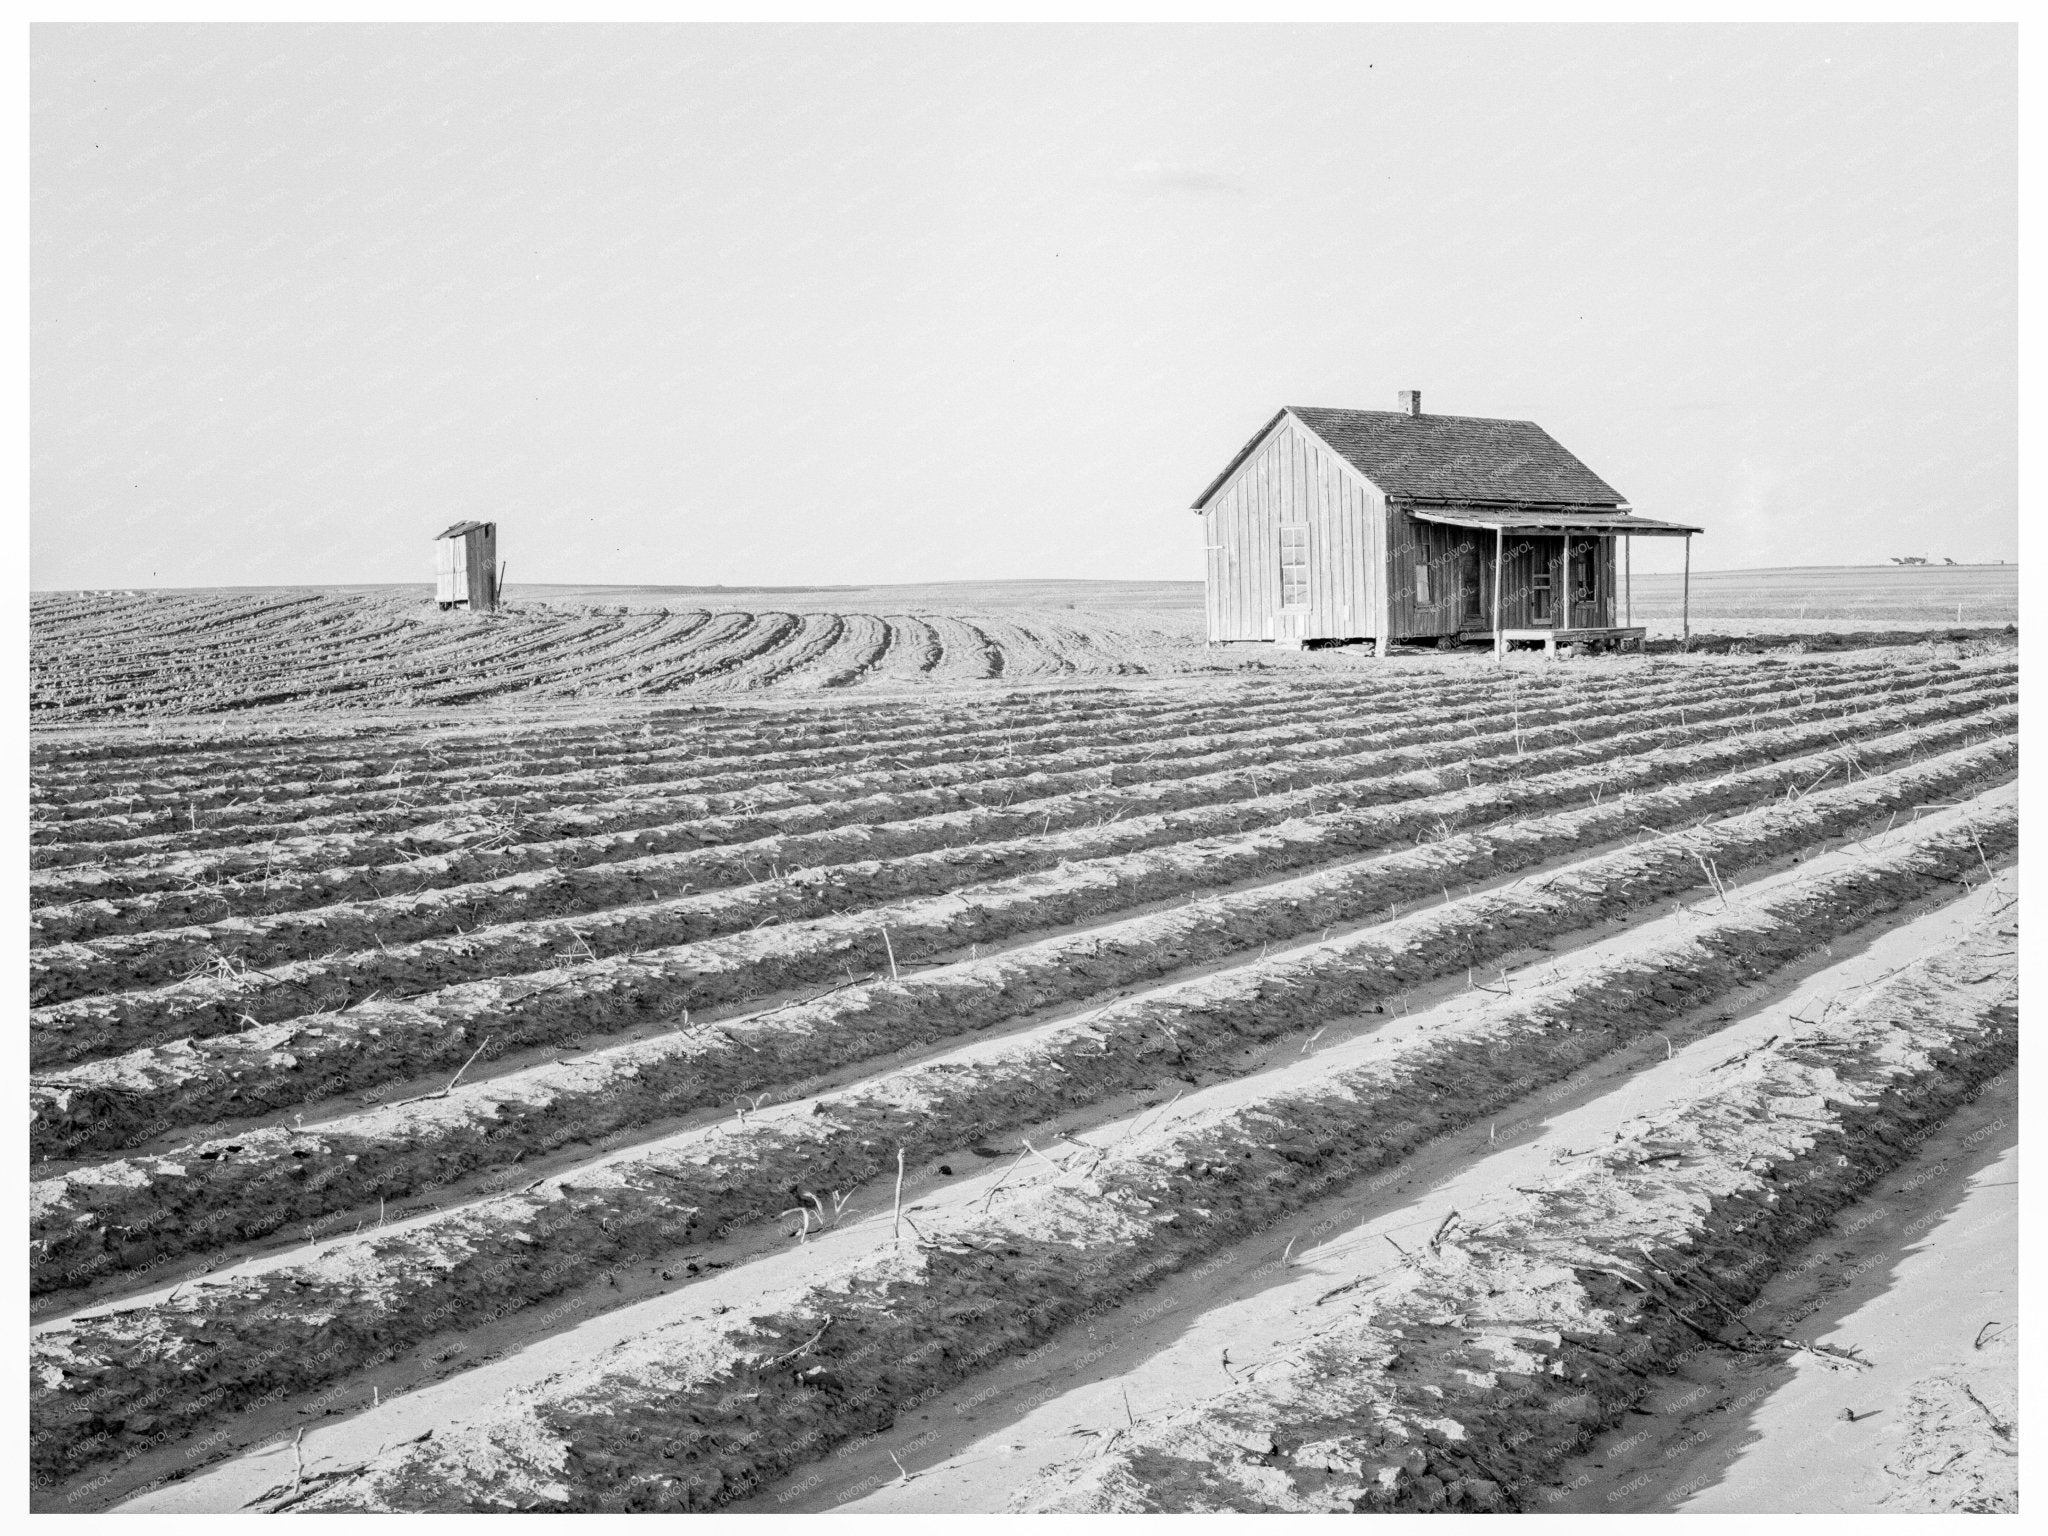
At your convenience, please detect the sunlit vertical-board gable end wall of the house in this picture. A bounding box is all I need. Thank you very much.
[1202,422,1382,641]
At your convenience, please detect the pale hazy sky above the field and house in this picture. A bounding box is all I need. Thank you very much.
[31,27,2017,588]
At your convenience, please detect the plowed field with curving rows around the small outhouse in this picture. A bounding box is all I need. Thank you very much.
[29,590,1204,721]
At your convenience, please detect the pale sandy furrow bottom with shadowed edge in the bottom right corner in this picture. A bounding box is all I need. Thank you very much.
[1546,1075,2019,1513]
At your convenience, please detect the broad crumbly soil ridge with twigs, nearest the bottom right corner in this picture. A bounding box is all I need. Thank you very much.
[1012,901,2017,1513]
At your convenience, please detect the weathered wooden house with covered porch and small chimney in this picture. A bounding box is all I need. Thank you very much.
[1194,389,1700,655]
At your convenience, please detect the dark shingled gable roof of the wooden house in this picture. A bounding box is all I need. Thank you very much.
[1194,406,1628,512]
